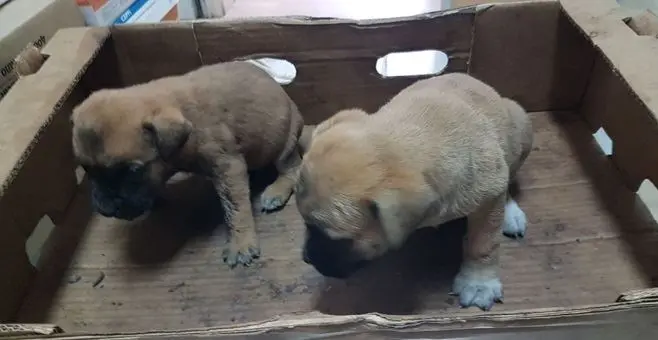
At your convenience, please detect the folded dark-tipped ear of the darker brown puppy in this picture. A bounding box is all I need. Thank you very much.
[142,110,192,159]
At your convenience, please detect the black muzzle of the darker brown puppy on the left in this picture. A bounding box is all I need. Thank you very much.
[90,180,155,221]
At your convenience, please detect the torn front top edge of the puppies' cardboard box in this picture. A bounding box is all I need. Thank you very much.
[10,289,658,340]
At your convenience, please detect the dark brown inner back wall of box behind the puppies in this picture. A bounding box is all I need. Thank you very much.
[113,1,593,124]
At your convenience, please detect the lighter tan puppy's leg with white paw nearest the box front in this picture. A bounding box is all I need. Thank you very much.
[453,194,507,310]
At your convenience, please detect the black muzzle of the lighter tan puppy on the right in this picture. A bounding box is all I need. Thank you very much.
[302,225,368,279]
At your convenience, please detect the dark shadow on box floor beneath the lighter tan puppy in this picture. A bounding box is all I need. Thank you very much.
[314,218,466,315]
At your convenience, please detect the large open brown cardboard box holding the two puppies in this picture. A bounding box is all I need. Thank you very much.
[0,0,658,339]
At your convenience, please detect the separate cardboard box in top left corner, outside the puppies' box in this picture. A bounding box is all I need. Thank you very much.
[0,0,84,98]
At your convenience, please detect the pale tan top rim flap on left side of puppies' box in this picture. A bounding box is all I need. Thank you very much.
[0,28,109,197]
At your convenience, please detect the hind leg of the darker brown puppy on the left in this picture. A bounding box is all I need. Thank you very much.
[260,114,304,211]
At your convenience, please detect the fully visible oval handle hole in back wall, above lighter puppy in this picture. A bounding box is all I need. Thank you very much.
[375,50,448,78]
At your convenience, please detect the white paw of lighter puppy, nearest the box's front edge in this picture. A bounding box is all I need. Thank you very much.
[452,269,503,311]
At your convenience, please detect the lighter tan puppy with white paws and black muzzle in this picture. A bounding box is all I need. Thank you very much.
[296,73,533,310]
